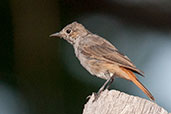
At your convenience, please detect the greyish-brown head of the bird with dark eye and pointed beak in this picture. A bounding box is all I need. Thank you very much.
[50,22,89,44]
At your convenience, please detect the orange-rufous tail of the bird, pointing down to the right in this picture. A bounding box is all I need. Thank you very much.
[120,67,155,101]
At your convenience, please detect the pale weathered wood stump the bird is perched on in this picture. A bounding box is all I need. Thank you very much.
[83,90,169,114]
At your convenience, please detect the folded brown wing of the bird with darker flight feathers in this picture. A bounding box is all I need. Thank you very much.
[81,35,144,76]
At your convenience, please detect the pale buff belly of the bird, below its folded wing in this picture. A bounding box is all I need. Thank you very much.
[78,56,130,80]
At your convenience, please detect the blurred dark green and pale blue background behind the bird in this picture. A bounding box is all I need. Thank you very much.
[0,0,171,114]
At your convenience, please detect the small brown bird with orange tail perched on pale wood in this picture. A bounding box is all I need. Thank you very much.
[50,22,154,101]
